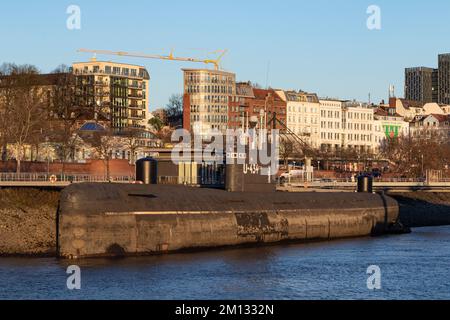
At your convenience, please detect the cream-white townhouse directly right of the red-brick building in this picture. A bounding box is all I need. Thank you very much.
[277,91,320,148]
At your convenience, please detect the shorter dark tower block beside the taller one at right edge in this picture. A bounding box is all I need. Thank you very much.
[405,67,438,103]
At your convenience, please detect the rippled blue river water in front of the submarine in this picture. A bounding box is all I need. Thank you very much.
[0,227,450,300]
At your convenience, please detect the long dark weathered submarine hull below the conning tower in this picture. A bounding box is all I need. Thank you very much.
[58,184,398,258]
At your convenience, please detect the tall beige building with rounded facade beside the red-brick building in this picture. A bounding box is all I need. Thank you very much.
[183,69,236,135]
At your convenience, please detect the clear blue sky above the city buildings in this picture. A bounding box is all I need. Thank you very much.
[0,0,450,109]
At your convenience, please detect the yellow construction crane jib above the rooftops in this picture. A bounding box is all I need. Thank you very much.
[78,49,228,70]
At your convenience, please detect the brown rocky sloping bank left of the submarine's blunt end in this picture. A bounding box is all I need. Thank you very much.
[0,189,60,256]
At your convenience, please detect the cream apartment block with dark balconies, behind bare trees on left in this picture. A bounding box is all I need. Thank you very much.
[72,59,150,131]
